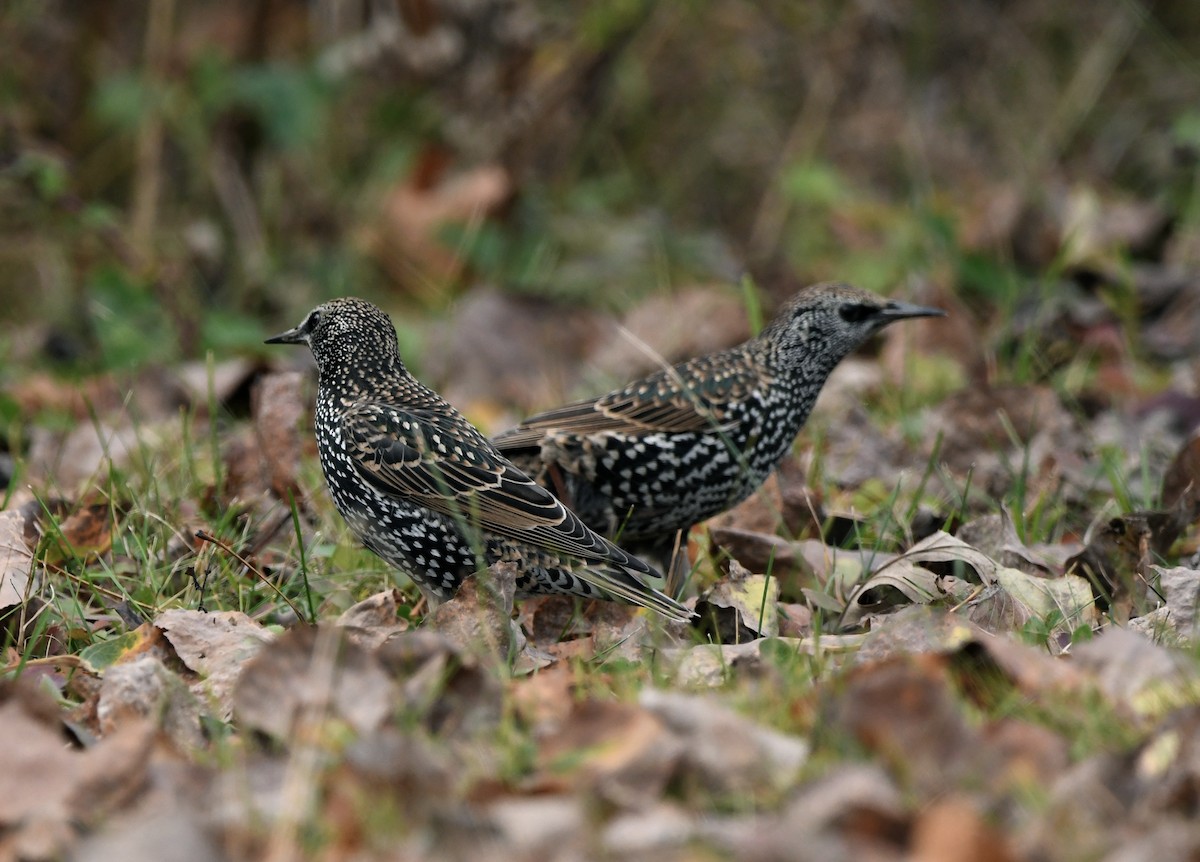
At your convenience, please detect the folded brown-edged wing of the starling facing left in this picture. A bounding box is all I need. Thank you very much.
[342,402,658,576]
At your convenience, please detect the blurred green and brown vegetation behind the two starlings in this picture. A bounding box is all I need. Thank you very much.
[0,0,1200,378]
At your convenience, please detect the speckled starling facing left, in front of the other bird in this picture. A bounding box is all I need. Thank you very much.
[266,298,692,619]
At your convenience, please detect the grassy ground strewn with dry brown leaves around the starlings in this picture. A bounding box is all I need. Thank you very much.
[7,298,1200,860]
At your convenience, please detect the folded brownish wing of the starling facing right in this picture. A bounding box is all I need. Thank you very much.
[496,354,763,451]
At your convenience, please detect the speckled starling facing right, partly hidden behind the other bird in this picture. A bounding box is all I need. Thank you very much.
[496,283,946,562]
